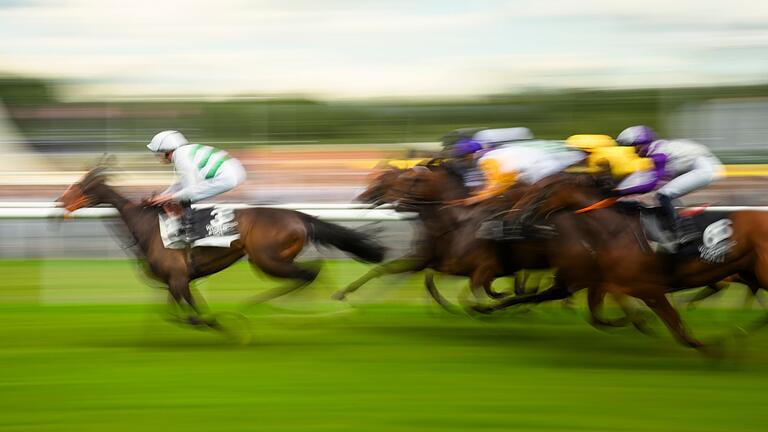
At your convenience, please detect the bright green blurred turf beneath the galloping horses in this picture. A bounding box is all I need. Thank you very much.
[0,261,768,431]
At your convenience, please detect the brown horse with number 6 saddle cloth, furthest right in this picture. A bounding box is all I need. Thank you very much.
[478,177,768,348]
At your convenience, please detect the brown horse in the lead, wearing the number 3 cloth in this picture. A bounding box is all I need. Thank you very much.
[58,168,384,324]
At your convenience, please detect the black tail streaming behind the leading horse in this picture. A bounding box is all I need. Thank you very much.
[303,215,386,263]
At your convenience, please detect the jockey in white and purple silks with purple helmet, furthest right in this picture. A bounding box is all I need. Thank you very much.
[616,126,723,247]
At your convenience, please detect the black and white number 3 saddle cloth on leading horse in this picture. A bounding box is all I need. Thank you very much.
[159,206,240,249]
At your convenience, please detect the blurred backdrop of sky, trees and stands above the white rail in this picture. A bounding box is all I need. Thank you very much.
[0,0,768,256]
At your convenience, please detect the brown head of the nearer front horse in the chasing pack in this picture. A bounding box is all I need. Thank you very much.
[383,166,463,210]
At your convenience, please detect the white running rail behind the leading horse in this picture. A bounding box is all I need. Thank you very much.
[0,201,415,222]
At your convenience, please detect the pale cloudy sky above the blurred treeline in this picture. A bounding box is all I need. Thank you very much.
[0,0,768,98]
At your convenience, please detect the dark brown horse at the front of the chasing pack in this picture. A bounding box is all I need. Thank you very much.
[334,164,548,308]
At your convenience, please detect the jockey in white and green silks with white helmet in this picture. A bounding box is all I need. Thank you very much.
[147,130,245,240]
